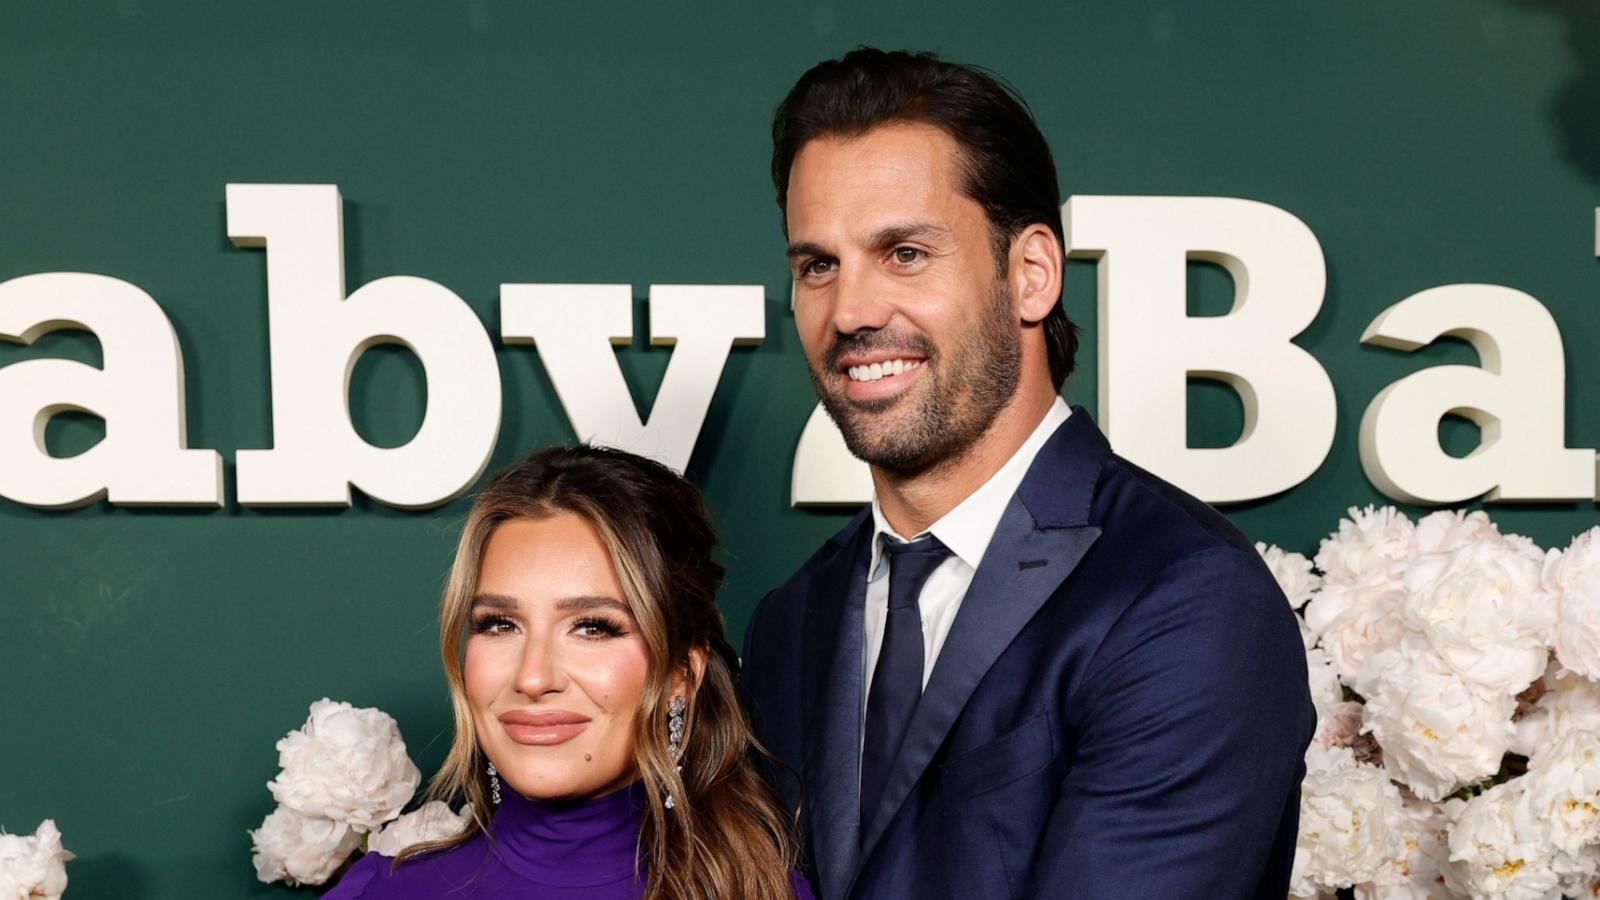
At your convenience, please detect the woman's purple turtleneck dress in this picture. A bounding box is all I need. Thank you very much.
[323,781,814,900]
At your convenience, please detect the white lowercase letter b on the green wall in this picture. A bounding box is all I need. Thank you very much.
[227,184,501,509]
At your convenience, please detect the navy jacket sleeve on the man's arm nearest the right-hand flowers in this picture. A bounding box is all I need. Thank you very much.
[1035,548,1315,900]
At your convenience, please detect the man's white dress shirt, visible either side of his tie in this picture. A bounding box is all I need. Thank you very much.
[861,397,1072,714]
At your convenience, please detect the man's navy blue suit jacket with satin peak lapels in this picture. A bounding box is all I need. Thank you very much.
[744,408,1315,900]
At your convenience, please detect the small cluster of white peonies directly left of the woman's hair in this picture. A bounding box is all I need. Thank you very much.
[246,698,467,883]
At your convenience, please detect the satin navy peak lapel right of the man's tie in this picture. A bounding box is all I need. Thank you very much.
[857,407,1110,864]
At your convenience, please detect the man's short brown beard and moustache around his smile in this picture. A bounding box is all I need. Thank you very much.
[810,282,1022,476]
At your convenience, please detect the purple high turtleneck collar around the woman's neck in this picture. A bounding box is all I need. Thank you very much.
[490,781,645,887]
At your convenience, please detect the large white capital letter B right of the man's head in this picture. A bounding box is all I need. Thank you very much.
[1062,197,1336,503]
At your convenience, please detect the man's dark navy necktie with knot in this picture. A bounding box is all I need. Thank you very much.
[861,535,950,825]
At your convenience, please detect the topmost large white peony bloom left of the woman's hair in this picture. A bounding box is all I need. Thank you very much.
[267,698,422,833]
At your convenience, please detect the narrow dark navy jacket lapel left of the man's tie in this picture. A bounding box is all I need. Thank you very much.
[802,511,872,897]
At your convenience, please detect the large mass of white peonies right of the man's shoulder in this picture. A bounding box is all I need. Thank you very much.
[1256,506,1600,900]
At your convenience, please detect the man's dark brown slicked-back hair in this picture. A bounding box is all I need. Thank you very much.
[773,46,1078,391]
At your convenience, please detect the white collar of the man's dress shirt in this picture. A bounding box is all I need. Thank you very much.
[867,397,1072,581]
